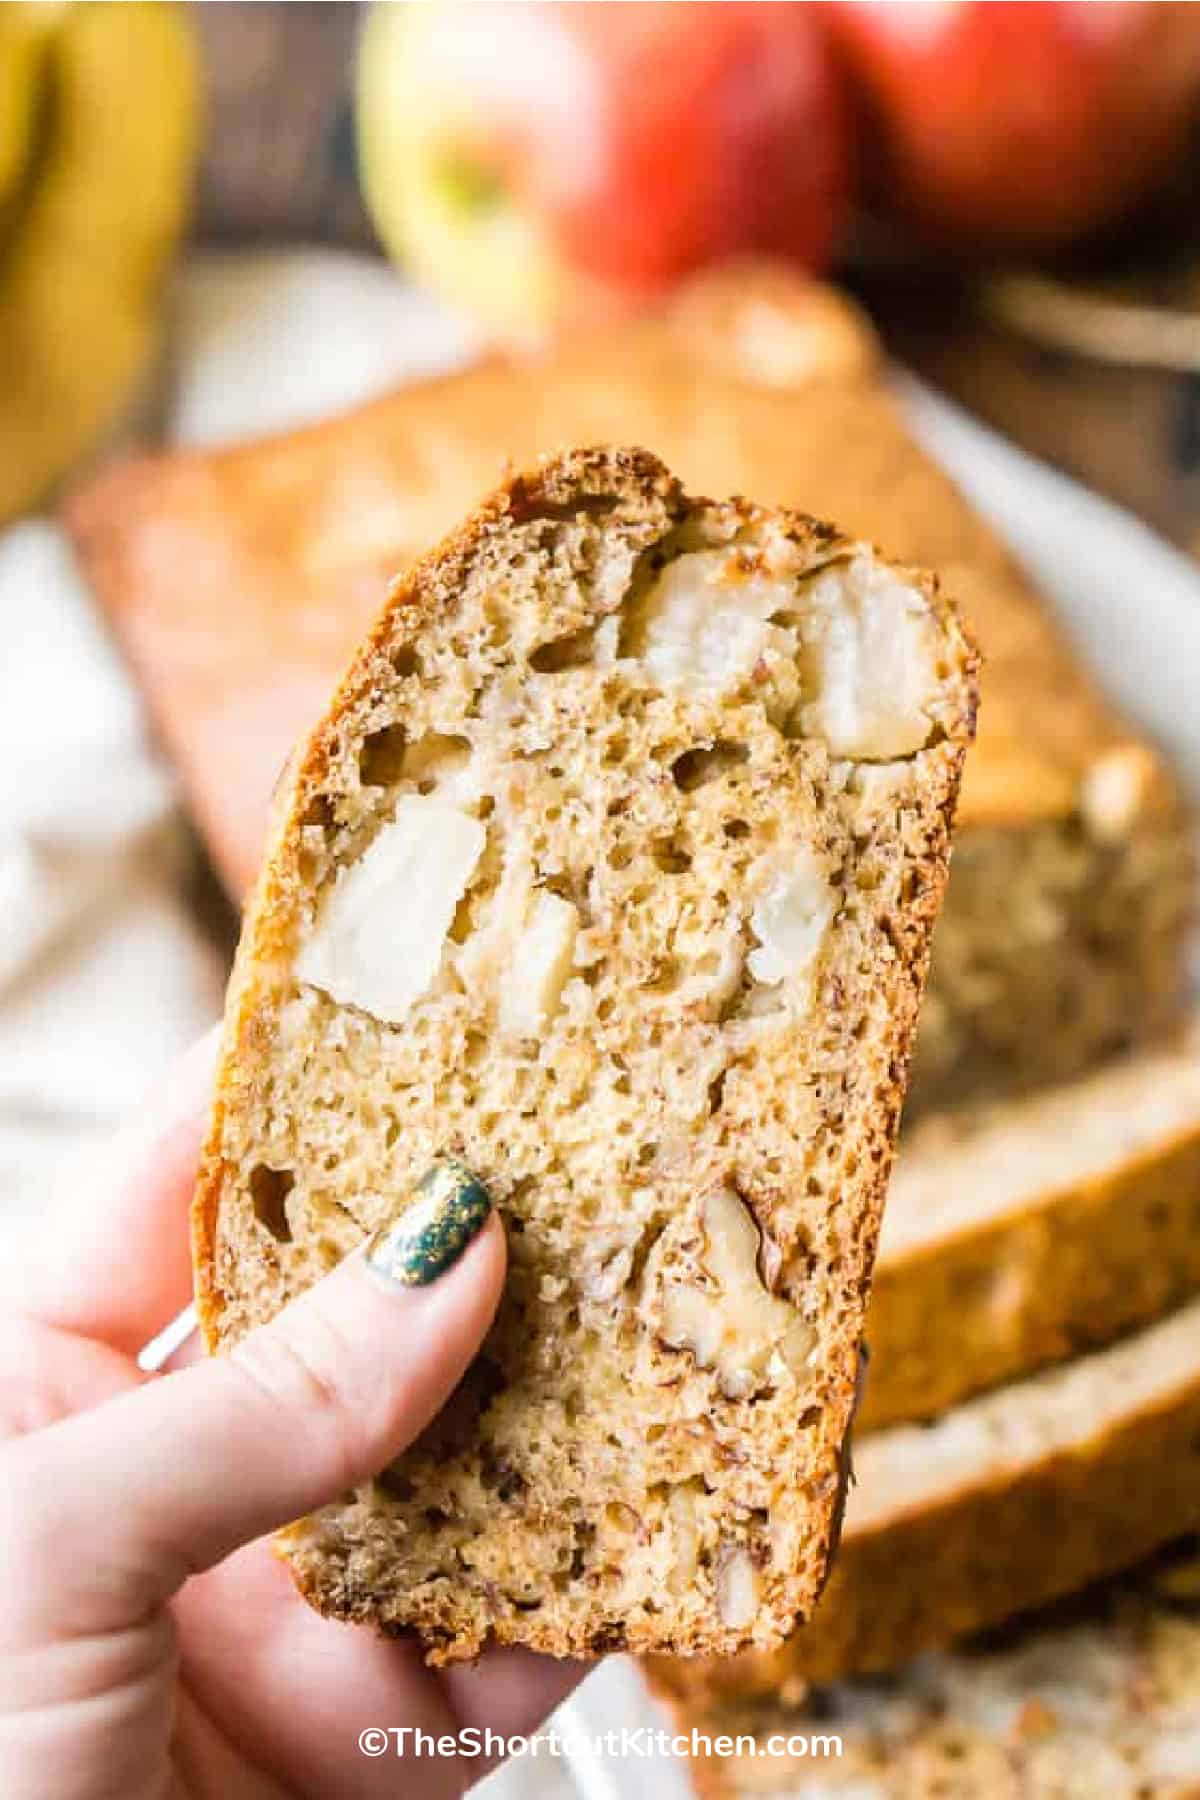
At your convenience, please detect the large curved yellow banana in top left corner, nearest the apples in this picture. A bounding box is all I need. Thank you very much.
[0,0,198,518]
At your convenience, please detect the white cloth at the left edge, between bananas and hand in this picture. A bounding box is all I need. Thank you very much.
[0,522,223,1219]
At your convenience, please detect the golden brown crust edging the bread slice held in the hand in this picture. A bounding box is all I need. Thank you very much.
[193,450,975,1661]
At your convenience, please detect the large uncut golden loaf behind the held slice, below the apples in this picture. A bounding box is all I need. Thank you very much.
[68,272,1193,1111]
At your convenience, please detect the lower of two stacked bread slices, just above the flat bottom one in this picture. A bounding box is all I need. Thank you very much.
[655,1300,1200,1703]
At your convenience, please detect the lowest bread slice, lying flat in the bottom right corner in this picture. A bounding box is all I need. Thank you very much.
[678,1541,1200,1800]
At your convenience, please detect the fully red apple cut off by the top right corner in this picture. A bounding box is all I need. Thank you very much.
[826,0,1200,248]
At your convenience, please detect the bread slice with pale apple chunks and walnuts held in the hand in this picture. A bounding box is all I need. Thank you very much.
[194,450,975,1661]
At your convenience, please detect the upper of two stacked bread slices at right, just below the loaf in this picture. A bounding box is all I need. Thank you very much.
[856,1030,1200,1433]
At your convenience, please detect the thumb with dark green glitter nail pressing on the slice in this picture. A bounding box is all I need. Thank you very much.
[0,1161,504,1642]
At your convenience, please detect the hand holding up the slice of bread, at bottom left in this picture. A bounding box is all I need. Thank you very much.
[0,1044,581,1800]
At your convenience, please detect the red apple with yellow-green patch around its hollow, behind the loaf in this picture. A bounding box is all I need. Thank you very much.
[360,4,849,331]
